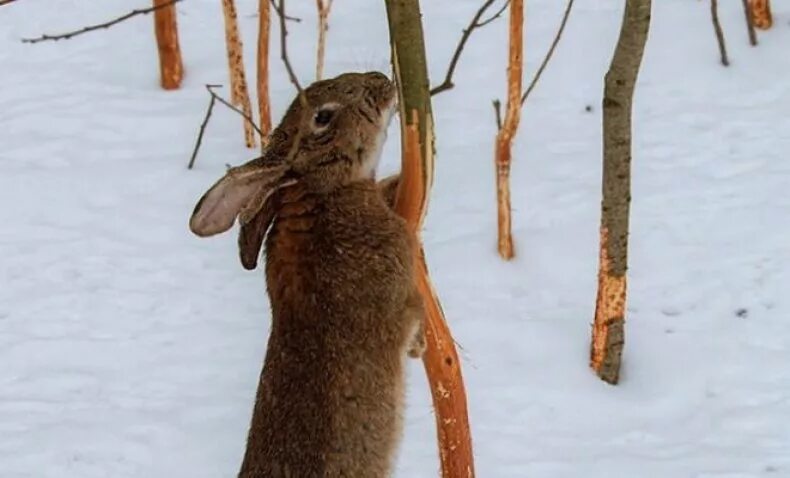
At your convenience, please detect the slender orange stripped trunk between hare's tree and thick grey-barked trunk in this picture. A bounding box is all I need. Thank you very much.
[495,0,524,259]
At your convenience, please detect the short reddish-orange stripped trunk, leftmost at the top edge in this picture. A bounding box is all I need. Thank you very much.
[154,0,184,90]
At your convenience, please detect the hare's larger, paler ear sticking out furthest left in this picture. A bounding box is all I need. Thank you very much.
[189,158,294,237]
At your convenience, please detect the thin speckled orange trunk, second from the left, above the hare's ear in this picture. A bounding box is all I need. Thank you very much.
[222,0,255,148]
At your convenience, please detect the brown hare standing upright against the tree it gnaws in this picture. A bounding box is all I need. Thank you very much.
[190,72,424,478]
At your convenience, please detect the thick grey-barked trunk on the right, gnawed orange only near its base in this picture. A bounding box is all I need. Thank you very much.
[590,0,651,384]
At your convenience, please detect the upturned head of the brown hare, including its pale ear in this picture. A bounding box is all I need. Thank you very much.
[189,72,396,267]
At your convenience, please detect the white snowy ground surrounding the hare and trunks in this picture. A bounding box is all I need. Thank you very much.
[0,0,790,478]
